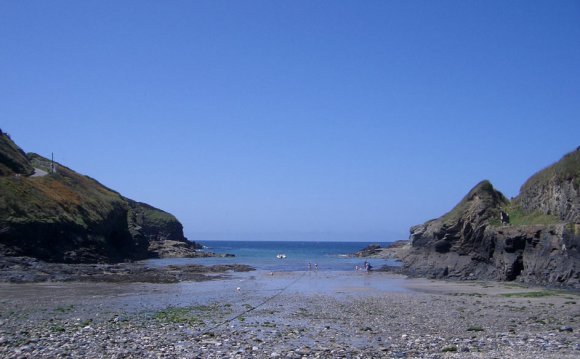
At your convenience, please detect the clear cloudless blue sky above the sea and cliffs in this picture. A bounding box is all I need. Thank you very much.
[0,1,580,241]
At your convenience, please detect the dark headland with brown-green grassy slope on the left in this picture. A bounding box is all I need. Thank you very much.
[0,131,202,263]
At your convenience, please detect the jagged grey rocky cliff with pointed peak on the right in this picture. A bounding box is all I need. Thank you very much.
[402,151,580,288]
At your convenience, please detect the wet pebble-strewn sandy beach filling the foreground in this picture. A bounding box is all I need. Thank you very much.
[0,272,580,358]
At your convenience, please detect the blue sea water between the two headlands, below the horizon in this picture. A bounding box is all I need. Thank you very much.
[147,241,398,271]
